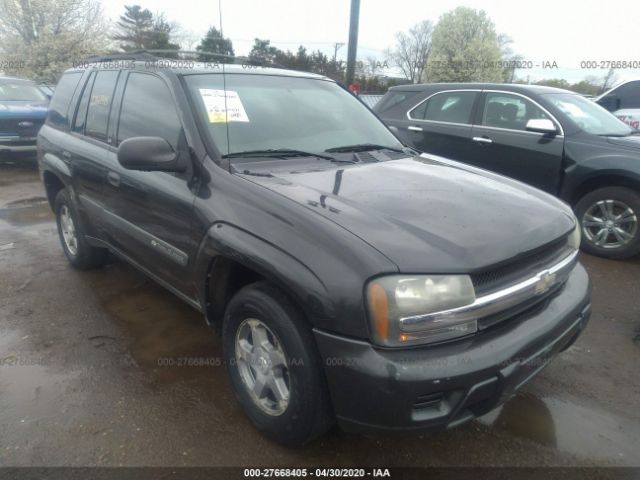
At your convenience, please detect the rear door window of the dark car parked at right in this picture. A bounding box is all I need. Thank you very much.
[409,92,477,123]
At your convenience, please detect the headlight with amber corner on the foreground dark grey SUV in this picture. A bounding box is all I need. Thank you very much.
[366,275,478,347]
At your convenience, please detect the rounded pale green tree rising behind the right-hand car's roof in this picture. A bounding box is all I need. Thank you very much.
[427,7,503,82]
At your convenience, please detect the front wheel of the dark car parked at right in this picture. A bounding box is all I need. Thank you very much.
[575,187,640,259]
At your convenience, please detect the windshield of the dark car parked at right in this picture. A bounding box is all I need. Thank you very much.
[546,93,633,137]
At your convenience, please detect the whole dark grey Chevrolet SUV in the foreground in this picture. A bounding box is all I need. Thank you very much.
[38,56,591,445]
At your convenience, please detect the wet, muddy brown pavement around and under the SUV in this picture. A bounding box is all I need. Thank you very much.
[0,160,640,467]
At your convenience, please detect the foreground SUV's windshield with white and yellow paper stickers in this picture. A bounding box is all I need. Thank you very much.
[186,74,402,154]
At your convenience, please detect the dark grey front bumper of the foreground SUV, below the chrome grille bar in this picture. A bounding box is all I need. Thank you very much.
[315,264,591,431]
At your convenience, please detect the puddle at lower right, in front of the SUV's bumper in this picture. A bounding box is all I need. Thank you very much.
[478,393,640,464]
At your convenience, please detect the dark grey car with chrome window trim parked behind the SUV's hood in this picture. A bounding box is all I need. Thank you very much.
[373,83,640,258]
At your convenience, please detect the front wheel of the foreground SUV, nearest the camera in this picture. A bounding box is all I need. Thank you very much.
[222,282,334,446]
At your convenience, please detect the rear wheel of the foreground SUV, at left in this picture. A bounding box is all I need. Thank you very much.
[54,188,109,270]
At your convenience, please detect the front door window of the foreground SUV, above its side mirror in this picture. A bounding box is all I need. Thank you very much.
[118,73,183,150]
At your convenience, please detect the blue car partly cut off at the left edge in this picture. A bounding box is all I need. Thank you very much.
[0,77,49,157]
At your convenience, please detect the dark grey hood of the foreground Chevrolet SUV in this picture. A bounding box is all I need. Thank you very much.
[236,156,574,273]
